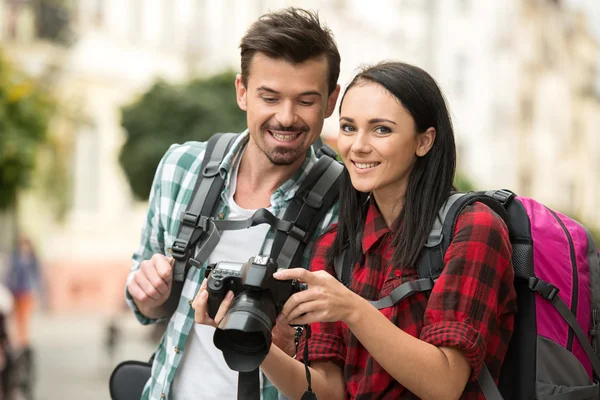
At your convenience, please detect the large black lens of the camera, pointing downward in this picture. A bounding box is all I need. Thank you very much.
[213,290,277,372]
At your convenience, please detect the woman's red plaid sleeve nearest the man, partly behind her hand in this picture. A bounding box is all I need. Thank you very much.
[296,229,346,364]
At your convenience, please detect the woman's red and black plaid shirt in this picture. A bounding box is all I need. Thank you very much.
[297,202,516,400]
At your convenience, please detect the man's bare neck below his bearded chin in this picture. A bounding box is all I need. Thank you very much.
[234,140,304,209]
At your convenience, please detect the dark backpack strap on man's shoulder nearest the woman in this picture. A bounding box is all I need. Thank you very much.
[271,156,344,268]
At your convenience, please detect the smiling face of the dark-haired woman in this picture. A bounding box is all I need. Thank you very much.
[337,81,435,201]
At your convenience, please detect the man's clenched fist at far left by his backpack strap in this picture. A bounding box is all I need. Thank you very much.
[127,254,174,318]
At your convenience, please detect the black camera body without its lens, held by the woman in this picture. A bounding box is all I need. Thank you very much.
[206,256,301,319]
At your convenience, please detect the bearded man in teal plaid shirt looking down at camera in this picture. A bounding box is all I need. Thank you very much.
[126,8,340,399]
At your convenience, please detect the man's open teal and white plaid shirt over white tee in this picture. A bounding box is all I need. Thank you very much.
[126,131,337,400]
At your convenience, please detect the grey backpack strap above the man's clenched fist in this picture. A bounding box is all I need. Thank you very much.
[172,133,238,282]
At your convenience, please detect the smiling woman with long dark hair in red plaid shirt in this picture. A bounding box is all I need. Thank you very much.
[194,63,516,400]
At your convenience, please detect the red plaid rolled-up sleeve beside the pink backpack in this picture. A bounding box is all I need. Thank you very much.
[420,203,516,380]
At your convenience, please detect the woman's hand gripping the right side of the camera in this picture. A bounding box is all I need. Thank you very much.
[273,268,361,325]
